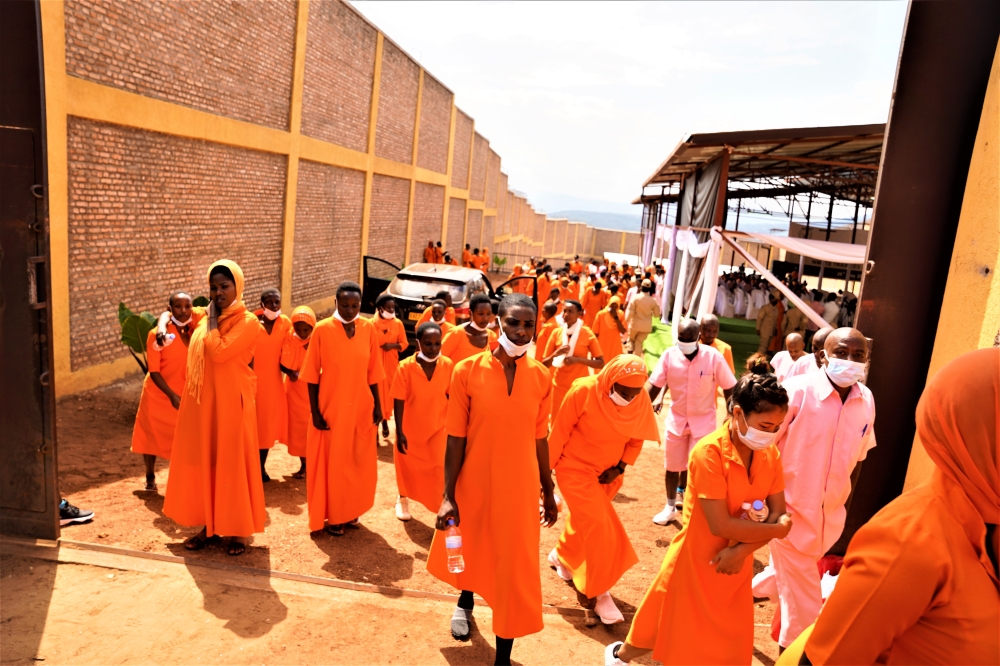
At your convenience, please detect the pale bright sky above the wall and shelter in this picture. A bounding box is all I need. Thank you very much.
[353,0,906,212]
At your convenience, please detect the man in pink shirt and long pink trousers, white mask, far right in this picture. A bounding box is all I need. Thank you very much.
[753,328,875,648]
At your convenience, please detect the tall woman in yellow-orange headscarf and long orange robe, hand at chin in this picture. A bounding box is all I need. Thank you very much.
[163,259,267,555]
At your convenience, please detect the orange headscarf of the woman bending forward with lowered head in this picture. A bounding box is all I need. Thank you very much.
[596,354,660,440]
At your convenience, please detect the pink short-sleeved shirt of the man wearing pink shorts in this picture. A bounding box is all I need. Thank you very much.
[649,344,736,438]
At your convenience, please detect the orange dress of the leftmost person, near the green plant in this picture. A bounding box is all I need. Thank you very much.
[132,315,197,460]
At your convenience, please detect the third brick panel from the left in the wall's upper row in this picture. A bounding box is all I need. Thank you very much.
[375,41,420,163]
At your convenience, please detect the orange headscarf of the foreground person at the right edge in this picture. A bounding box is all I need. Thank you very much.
[917,348,1000,524]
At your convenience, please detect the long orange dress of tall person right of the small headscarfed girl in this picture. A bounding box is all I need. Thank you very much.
[299,317,385,532]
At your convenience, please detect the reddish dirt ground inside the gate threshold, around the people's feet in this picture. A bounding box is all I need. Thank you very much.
[52,370,777,664]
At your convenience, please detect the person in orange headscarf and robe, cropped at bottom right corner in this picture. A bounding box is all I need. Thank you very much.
[778,347,1000,664]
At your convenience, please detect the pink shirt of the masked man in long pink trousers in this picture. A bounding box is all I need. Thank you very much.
[776,372,875,559]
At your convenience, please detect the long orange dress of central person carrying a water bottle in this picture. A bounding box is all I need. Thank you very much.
[427,354,552,638]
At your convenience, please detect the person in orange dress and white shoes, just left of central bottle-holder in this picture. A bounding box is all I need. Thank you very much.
[391,320,454,521]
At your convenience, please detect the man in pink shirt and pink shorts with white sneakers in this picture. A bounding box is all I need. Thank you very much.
[647,319,736,525]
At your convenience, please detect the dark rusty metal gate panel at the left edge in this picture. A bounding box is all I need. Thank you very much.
[0,2,59,539]
